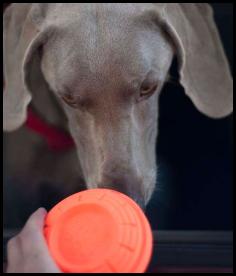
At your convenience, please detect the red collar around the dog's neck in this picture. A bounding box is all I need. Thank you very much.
[26,108,74,151]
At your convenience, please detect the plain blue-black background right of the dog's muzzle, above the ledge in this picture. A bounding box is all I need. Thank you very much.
[147,3,233,230]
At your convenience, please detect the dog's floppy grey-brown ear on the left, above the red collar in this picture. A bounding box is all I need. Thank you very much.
[3,3,51,131]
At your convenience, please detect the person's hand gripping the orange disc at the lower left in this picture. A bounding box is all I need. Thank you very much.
[6,208,61,273]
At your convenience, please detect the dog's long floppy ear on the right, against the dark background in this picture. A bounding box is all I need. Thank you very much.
[157,3,233,118]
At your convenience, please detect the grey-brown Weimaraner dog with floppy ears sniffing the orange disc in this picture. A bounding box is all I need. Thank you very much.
[3,3,233,209]
